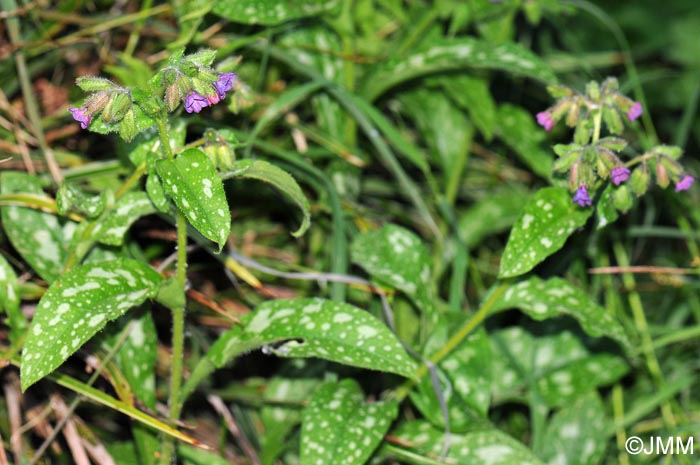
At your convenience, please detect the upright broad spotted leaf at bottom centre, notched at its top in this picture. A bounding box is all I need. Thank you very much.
[300,379,398,465]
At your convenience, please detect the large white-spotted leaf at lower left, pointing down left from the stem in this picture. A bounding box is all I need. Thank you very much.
[21,259,163,390]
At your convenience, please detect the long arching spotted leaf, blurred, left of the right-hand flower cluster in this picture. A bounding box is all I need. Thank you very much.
[363,37,557,101]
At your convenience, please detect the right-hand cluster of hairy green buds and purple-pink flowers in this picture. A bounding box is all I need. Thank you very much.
[536,78,695,211]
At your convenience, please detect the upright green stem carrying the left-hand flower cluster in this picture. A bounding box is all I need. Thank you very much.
[158,117,187,465]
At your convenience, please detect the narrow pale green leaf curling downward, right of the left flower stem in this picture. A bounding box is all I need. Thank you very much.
[222,160,311,237]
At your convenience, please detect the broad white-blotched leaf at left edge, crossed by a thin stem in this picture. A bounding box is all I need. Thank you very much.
[0,171,66,283]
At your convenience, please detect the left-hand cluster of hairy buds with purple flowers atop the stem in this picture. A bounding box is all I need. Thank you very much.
[70,50,238,141]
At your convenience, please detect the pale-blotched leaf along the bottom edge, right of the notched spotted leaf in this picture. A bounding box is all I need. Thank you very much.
[391,420,543,465]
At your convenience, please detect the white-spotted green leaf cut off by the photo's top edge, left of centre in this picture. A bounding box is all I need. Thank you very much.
[212,0,340,26]
